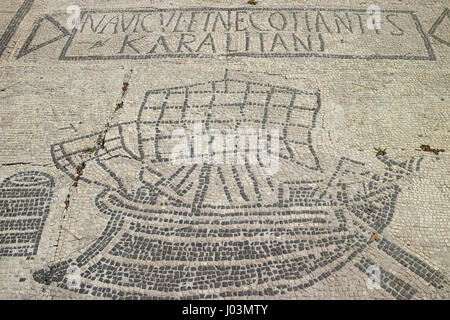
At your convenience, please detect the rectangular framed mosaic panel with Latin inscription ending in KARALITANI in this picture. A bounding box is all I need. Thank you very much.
[60,8,434,60]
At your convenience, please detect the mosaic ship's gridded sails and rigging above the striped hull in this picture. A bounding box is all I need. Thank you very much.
[52,78,321,207]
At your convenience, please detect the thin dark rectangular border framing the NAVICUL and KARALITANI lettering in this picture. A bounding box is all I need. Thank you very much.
[59,7,436,61]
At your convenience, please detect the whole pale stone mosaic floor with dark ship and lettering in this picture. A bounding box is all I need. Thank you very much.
[0,0,450,299]
